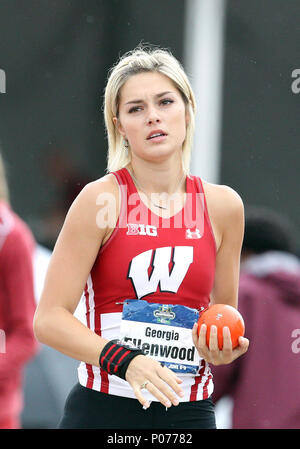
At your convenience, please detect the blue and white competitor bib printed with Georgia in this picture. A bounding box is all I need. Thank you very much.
[120,299,200,375]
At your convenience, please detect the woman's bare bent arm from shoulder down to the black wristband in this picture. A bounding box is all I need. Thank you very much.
[33,177,116,366]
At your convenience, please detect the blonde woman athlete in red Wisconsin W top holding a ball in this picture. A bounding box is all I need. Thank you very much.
[34,44,248,428]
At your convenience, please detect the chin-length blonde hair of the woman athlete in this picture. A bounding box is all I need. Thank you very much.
[104,46,196,174]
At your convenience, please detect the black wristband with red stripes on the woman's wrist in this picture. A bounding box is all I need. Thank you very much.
[99,340,144,380]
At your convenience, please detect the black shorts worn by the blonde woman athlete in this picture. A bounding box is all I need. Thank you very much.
[58,383,216,429]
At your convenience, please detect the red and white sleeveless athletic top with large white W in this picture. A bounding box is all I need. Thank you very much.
[78,168,216,401]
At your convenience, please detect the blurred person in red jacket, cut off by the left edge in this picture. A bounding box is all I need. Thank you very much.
[0,153,38,429]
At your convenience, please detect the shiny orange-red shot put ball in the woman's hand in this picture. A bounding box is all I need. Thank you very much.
[198,304,245,349]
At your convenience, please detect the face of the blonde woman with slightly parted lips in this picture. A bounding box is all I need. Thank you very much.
[115,72,187,161]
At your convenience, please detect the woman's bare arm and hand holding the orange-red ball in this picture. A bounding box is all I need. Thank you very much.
[193,186,249,365]
